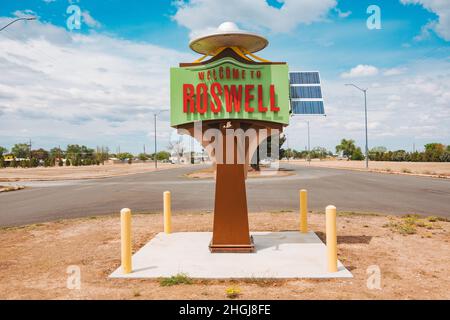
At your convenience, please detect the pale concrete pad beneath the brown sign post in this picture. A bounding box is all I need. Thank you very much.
[110,231,353,279]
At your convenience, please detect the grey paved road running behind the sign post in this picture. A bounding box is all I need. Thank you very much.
[0,164,450,226]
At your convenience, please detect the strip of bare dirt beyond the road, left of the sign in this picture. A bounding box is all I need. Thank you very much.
[0,161,185,182]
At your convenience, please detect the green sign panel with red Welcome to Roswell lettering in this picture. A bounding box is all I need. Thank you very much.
[170,57,289,127]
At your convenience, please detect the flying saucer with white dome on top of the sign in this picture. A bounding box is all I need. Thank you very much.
[189,22,269,55]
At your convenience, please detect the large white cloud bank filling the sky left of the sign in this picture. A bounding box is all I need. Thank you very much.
[0,18,194,152]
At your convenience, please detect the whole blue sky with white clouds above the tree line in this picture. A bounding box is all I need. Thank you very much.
[0,0,450,153]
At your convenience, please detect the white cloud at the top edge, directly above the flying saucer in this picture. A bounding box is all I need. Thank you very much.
[173,0,337,35]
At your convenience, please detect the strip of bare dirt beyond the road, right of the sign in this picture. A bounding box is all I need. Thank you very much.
[283,159,450,178]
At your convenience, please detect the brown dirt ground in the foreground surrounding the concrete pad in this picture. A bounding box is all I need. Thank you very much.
[0,211,450,299]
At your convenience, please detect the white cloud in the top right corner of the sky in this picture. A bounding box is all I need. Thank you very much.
[400,0,450,41]
